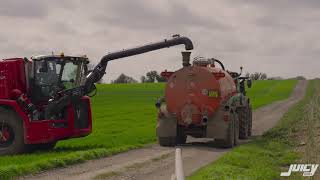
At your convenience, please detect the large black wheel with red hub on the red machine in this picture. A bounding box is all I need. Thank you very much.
[0,108,27,155]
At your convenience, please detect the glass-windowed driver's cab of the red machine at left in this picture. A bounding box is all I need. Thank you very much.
[29,54,89,104]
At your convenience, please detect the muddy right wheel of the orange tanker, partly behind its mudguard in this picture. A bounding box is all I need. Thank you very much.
[215,113,239,148]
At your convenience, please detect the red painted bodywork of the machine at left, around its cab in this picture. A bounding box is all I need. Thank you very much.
[0,58,92,144]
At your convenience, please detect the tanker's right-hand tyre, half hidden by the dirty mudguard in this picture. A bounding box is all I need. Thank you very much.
[215,113,238,148]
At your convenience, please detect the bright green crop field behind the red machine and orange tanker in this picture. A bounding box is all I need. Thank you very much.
[0,80,297,179]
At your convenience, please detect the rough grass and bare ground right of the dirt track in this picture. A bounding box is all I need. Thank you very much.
[188,80,320,180]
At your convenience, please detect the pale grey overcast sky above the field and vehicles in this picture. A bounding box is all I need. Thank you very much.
[0,0,320,81]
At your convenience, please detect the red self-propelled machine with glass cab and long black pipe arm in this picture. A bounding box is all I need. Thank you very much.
[0,36,193,155]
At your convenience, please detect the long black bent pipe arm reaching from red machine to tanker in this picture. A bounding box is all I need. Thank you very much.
[84,35,193,93]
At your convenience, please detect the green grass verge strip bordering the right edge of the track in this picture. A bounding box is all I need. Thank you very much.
[189,80,320,180]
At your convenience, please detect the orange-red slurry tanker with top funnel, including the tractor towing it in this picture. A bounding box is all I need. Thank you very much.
[156,52,252,148]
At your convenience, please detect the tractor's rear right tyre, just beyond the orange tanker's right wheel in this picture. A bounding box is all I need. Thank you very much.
[237,107,249,139]
